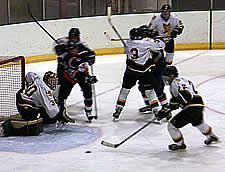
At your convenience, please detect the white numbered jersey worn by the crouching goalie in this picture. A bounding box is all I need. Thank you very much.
[19,72,59,118]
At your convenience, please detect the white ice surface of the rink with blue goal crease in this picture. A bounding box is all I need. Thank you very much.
[0,50,225,172]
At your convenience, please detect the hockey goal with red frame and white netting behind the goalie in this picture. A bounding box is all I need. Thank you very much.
[0,56,25,120]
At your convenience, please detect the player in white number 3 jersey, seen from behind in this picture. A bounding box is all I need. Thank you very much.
[113,28,165,121]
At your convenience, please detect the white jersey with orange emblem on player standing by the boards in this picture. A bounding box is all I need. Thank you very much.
[149,14,182,35]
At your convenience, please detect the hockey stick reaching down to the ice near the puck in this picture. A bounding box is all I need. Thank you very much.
[101,118,156,148]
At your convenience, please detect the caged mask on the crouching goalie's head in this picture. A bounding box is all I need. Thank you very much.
[43,71,58,90]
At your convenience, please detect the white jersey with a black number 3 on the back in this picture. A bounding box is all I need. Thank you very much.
[125,38,165,72]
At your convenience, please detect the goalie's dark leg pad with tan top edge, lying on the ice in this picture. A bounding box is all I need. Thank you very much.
[0,118,43,137]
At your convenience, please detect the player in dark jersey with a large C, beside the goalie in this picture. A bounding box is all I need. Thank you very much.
[55,28,97,121]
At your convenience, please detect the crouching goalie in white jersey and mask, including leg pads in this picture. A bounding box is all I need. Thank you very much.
[0,71,75,136]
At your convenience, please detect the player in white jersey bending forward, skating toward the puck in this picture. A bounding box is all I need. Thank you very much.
[156,66,219,150]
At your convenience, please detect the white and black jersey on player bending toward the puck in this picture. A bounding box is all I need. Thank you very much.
[170,77,200,107]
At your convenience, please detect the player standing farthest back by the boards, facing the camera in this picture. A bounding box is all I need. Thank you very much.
[149,4,184,64]
